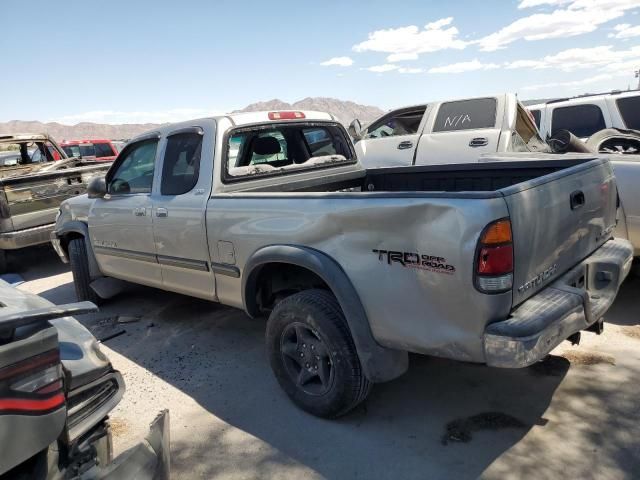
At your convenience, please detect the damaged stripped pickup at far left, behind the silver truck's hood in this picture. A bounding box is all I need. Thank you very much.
[0,134,110,273]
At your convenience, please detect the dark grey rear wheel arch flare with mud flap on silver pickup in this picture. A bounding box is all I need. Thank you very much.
[242,245,409,382]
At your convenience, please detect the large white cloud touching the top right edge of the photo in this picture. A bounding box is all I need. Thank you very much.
[474,0,640,52]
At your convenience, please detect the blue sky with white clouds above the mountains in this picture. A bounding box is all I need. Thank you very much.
[0,0,640,124]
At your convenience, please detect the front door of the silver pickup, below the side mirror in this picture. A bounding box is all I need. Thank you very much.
[88,135,162,287]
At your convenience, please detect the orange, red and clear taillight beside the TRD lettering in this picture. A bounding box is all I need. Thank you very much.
[475,219,513,293]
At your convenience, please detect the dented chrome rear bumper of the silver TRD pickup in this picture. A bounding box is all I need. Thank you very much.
[483,238,633,368]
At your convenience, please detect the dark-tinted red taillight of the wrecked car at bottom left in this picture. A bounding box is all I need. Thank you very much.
[0,350,65,414]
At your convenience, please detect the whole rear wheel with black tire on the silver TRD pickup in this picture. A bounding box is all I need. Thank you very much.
[266,289,372,418]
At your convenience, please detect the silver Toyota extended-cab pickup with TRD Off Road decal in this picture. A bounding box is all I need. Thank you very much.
[52,112,632,417]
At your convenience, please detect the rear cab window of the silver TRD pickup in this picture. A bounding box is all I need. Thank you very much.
[226,125,353,177]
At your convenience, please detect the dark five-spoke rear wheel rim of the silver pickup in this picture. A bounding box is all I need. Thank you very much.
[280,322,335,395]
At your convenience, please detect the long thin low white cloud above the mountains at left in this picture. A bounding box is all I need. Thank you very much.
[47,108,223,125]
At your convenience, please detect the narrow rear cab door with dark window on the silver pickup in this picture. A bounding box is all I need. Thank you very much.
[152,127,215,300]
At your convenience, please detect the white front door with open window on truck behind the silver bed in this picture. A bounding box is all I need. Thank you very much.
[355,105,426,168]
